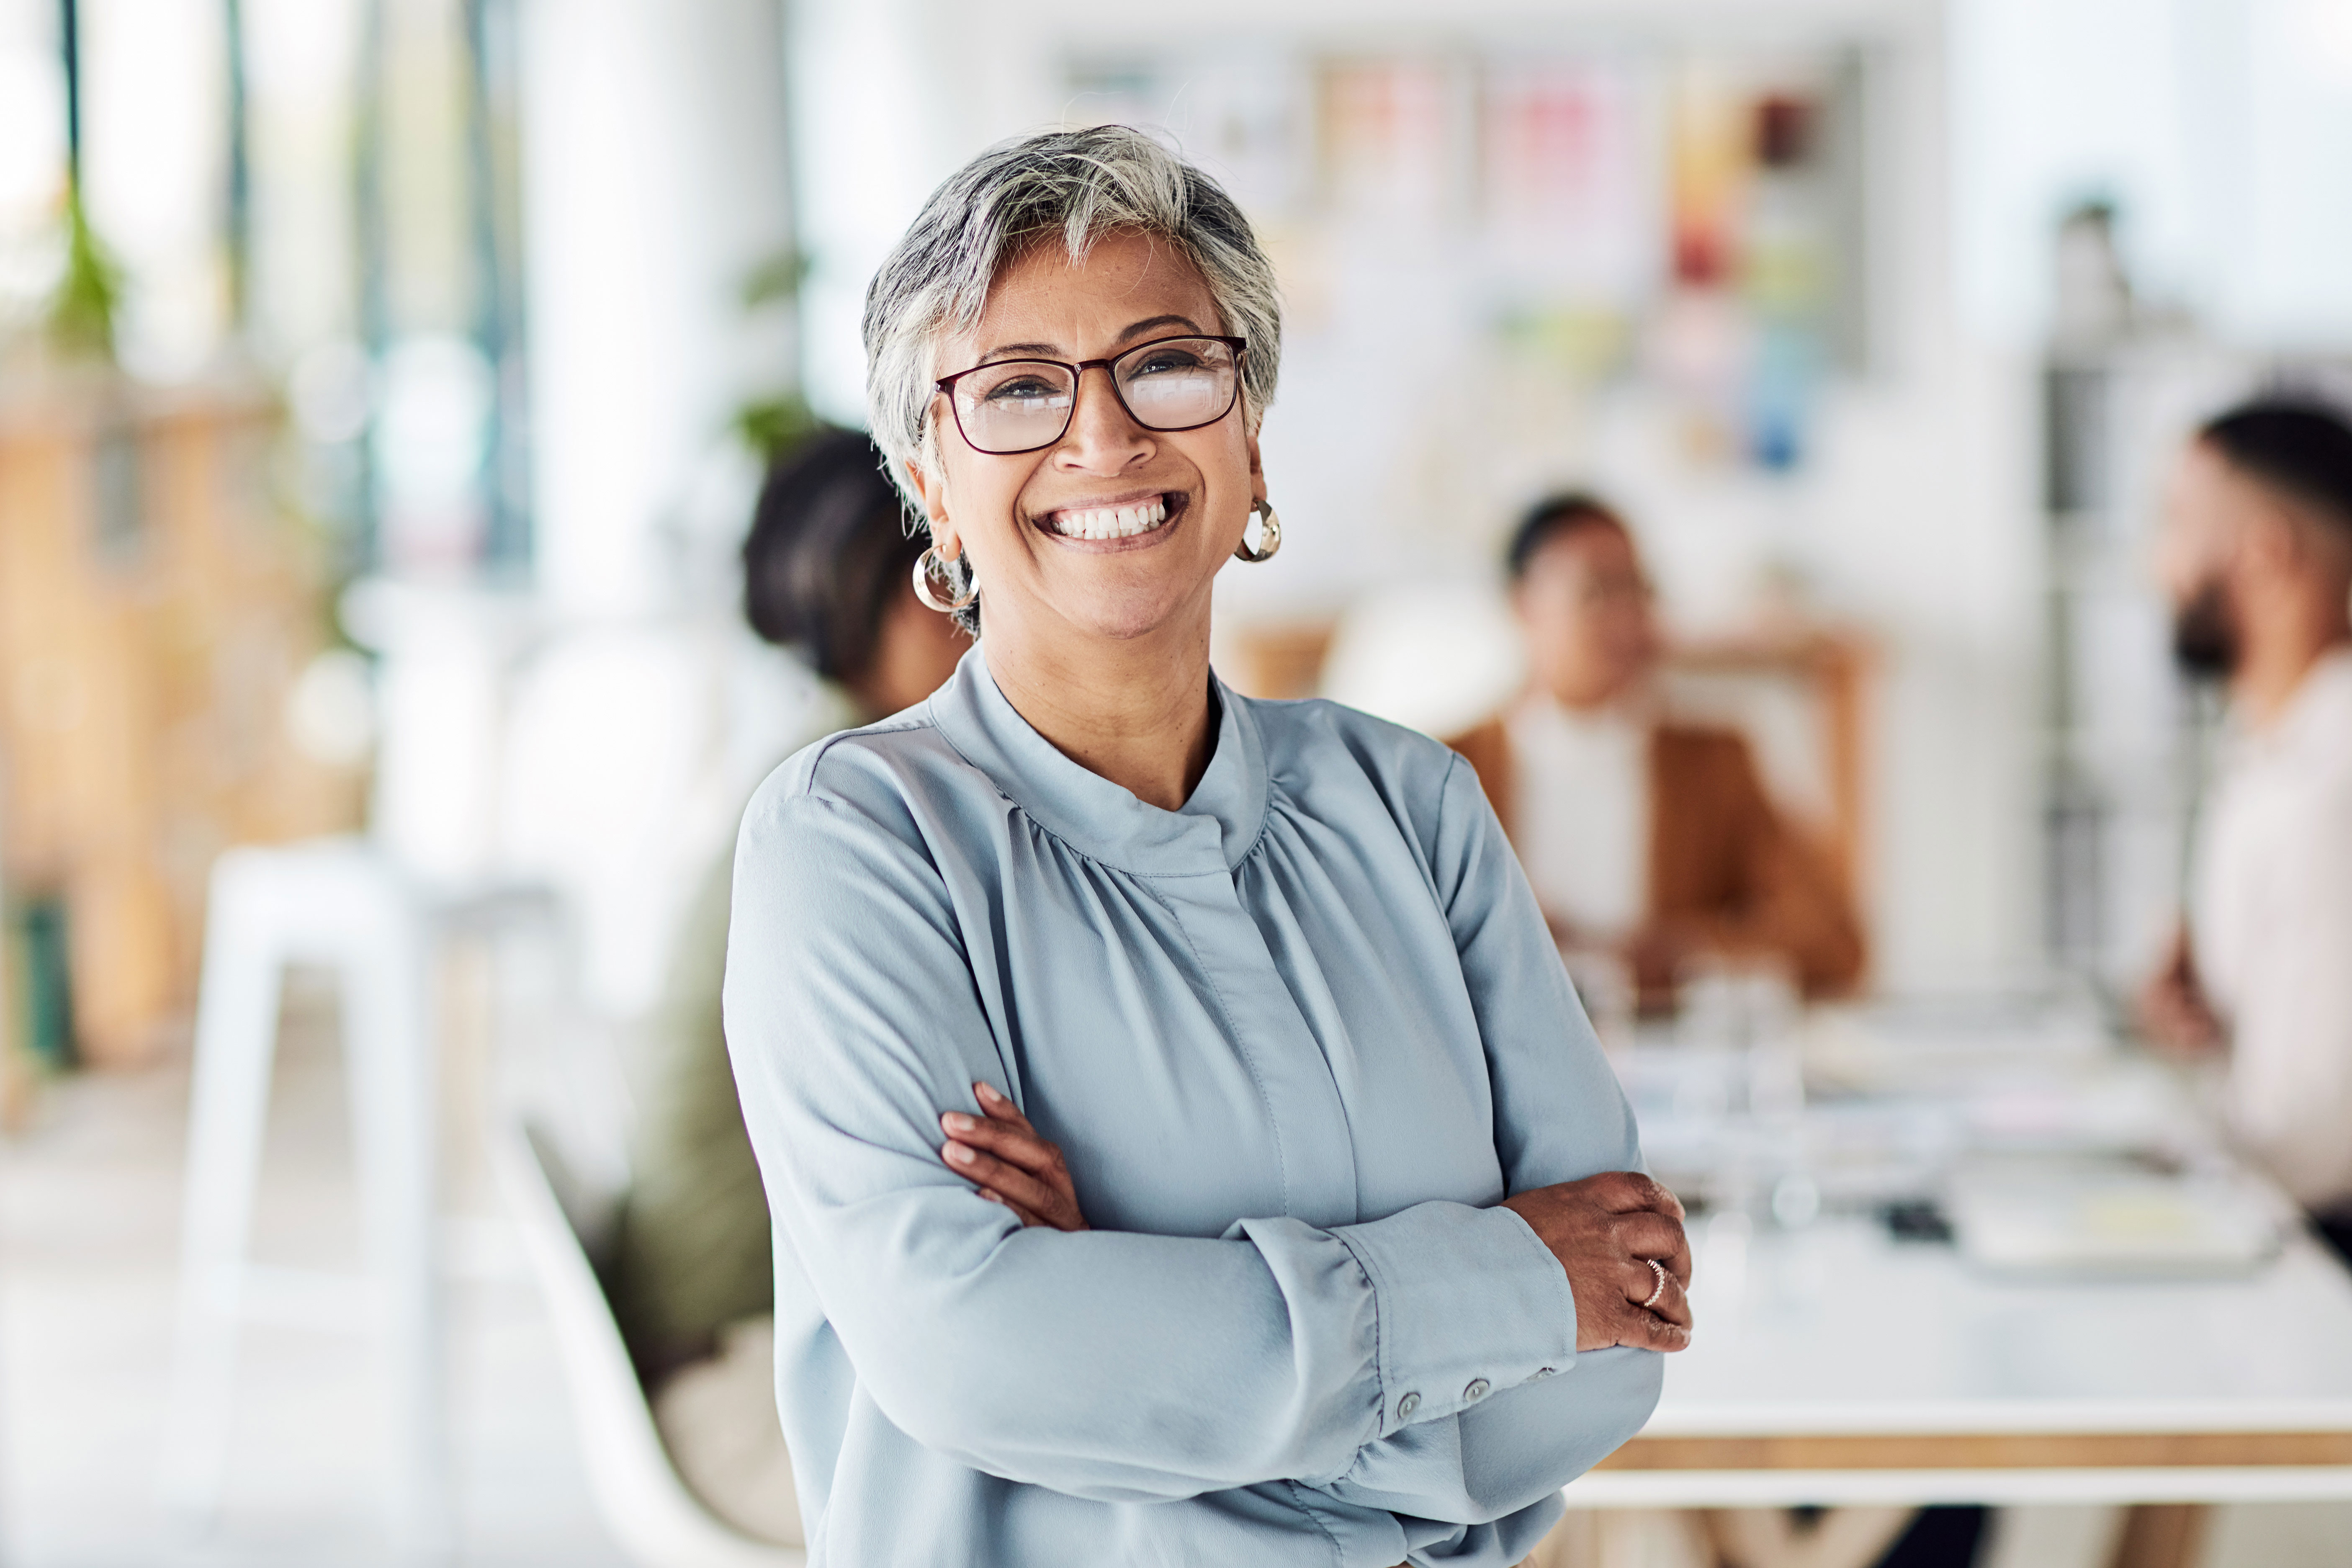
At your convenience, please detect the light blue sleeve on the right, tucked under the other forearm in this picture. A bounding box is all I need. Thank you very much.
[1329,760,1665,1523]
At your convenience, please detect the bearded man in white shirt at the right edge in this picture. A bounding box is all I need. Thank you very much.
[2140,402,2352,1258]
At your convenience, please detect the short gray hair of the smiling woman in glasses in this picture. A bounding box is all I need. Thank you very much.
[865,125,1282,517]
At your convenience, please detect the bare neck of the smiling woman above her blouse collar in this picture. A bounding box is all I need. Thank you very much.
[981,609,1216,811]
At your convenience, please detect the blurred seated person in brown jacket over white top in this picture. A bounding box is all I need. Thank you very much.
[1454,496,1863,1006]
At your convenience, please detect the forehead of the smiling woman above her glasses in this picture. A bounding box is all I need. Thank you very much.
[957,233,1223,355]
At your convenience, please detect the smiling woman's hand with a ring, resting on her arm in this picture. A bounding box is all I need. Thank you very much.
[1503,1171,1691,1349]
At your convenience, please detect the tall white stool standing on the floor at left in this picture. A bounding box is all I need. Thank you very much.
[165,839,452,1552]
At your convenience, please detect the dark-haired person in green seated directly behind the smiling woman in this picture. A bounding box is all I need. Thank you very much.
[609,430,969,1542]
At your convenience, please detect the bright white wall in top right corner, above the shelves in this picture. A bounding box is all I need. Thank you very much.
[1952,0,2352,350]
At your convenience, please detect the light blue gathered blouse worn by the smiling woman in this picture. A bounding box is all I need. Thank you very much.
[724,649,1660,1568]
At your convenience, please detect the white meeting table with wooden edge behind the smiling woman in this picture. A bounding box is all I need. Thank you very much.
[1567,1025,2352,1563]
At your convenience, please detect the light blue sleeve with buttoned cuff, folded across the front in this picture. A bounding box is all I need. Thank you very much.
[724,778,1576,1500]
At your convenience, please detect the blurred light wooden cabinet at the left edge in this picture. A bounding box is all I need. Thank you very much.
[0,371,365,1065]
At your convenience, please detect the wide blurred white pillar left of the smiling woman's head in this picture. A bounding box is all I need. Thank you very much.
[520,0,793,613]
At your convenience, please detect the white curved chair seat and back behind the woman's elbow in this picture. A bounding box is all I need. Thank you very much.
[492,1121,807,1568]
